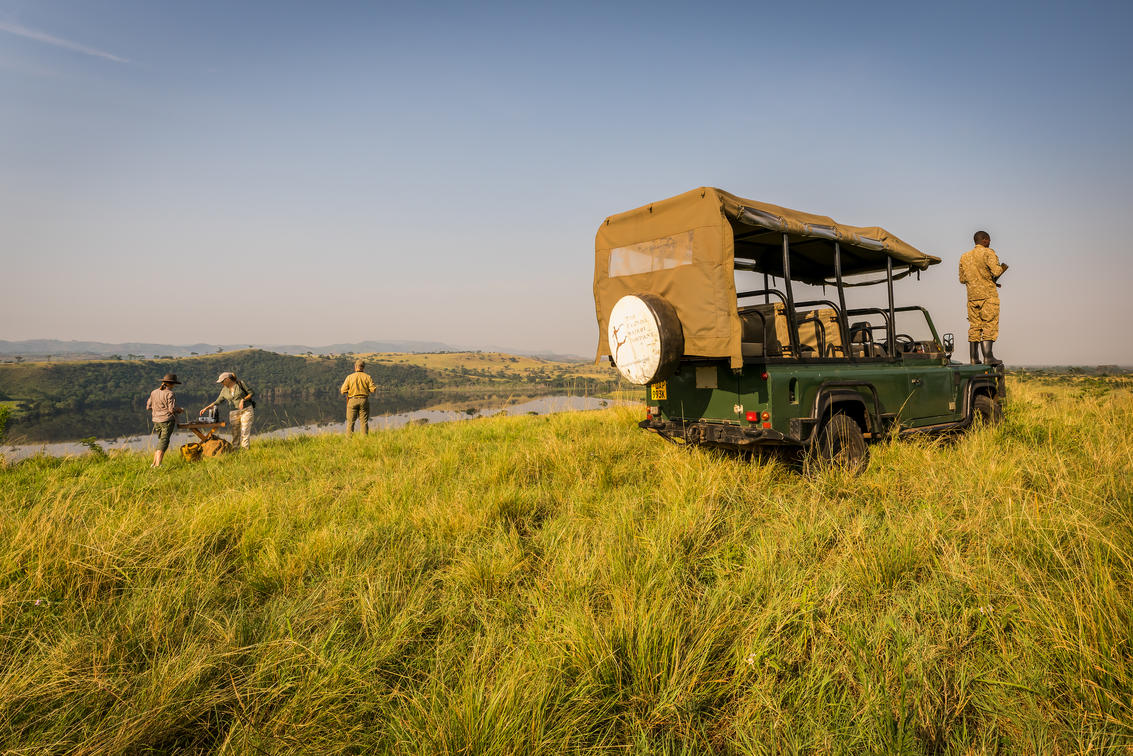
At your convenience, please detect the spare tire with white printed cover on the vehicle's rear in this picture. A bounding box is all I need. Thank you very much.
[606,294,684,385]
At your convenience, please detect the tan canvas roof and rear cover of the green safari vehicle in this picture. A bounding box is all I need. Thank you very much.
[594,187,940,367]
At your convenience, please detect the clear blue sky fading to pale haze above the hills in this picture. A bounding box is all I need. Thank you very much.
[0,0,1133,365]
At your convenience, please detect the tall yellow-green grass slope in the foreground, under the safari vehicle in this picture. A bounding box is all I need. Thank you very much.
[0,382,1133,754]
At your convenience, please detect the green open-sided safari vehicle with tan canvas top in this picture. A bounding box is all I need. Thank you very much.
[594,187,1006,467]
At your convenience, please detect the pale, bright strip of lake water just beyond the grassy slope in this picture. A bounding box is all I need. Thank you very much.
[0,394,622,462]
